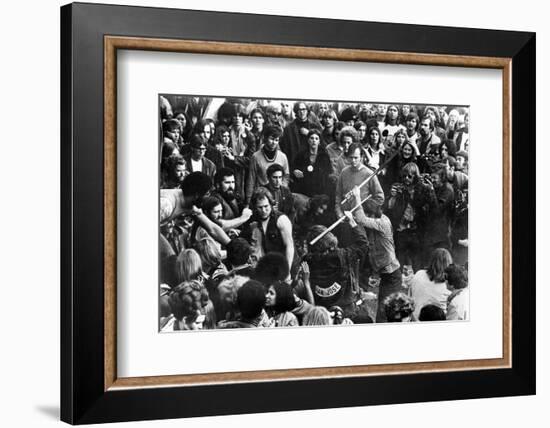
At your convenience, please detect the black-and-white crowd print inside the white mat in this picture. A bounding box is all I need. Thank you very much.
[159,95,469,331]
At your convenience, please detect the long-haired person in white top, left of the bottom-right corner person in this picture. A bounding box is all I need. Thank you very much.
[410,248,453,319]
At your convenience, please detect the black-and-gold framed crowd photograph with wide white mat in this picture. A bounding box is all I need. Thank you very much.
[61,3,535,424]
